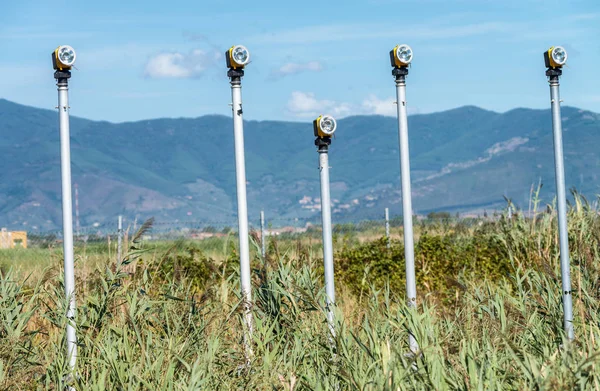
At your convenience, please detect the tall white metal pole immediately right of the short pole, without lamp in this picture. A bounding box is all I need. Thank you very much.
[396,71,419,353]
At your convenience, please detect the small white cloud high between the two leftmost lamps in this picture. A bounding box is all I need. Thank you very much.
[145,49,221,79]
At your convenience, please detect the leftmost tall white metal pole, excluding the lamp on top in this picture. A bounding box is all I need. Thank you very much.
[56,74,77,370]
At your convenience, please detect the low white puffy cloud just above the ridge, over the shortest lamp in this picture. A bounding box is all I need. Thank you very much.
[287,91,418,118]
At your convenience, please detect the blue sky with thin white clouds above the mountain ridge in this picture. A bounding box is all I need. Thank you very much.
[0,0,600,122]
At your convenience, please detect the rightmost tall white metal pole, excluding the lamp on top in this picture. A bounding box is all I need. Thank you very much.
[549,75,575,340]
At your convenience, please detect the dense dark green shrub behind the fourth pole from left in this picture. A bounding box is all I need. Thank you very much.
[335,229,510,296]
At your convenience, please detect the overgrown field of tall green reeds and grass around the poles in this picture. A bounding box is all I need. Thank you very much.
[0,197,600,390]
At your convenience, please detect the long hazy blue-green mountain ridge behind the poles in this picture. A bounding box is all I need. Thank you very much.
[0,99,600,230]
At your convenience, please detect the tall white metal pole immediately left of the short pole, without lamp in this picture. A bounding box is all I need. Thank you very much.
[231,76,254,352]
